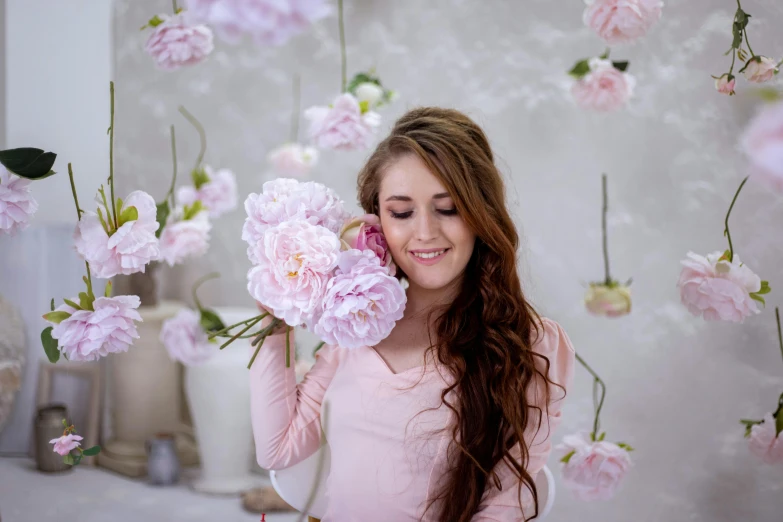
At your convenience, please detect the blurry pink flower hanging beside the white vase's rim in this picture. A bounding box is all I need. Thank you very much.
[160,308,218,366]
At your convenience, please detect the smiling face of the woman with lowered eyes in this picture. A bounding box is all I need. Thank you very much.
[378,154,476,290]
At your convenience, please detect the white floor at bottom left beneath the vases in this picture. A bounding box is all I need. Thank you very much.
[0,458,306,522]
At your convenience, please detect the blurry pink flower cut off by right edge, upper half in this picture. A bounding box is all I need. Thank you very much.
[741,102,783,194]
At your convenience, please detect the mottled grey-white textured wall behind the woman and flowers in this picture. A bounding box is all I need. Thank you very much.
[115,0,783,522]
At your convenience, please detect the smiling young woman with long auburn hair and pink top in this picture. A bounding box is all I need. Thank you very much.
[250,107,574,522]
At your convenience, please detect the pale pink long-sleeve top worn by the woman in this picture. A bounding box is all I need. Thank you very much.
[250,318,574,522]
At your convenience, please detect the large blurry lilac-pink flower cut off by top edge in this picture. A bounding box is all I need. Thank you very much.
[185,0,331,45]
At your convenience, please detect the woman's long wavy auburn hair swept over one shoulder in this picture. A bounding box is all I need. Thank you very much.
[358,107,551,522]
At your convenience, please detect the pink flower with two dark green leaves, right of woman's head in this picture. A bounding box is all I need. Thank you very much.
[571,58,636,111]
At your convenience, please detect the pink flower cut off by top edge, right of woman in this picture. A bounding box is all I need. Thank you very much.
[583,0,663,45]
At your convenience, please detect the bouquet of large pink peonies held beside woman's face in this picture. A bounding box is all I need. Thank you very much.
[210,178,406,367]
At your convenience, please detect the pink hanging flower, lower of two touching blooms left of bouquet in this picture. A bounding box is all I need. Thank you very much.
[160,209,212,266]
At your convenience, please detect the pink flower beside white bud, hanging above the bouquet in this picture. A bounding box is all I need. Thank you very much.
[305,93,381,150]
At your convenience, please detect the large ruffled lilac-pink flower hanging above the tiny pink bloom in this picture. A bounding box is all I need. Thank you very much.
[52,295,142,361]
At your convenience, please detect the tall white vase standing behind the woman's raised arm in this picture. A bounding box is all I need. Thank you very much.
[185,307,259,495]
